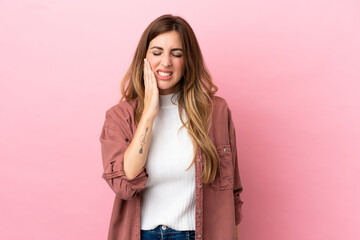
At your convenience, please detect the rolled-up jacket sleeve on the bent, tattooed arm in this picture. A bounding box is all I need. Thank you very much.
[100,111,148,200]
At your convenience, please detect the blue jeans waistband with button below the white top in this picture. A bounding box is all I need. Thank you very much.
[141,225,195,240]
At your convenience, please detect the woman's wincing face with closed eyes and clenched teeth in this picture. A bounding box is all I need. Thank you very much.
[146,31,184,95]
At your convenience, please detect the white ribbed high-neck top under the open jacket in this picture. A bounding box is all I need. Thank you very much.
[141,93,195,231]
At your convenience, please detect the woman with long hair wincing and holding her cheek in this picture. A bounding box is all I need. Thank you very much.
[100,15,243,240]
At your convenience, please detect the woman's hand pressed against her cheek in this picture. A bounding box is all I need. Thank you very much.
[142,58,160,119]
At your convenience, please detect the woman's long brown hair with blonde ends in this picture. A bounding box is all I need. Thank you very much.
[120,14,219,183]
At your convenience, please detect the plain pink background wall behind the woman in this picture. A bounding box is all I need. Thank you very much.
[0,0,360,240]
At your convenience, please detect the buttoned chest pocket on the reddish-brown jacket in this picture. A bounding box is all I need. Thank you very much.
[210,144,234,191]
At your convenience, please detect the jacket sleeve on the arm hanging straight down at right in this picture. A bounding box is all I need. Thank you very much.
[228,108,243,225]
